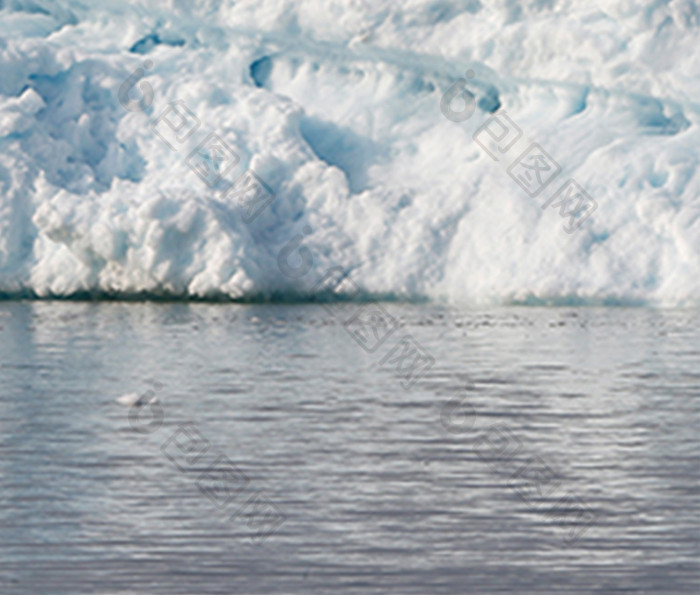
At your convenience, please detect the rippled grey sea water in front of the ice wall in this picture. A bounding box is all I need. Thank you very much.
[0,302,700,594]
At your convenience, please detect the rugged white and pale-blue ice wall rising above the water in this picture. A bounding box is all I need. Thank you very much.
[0,0,700,306]
